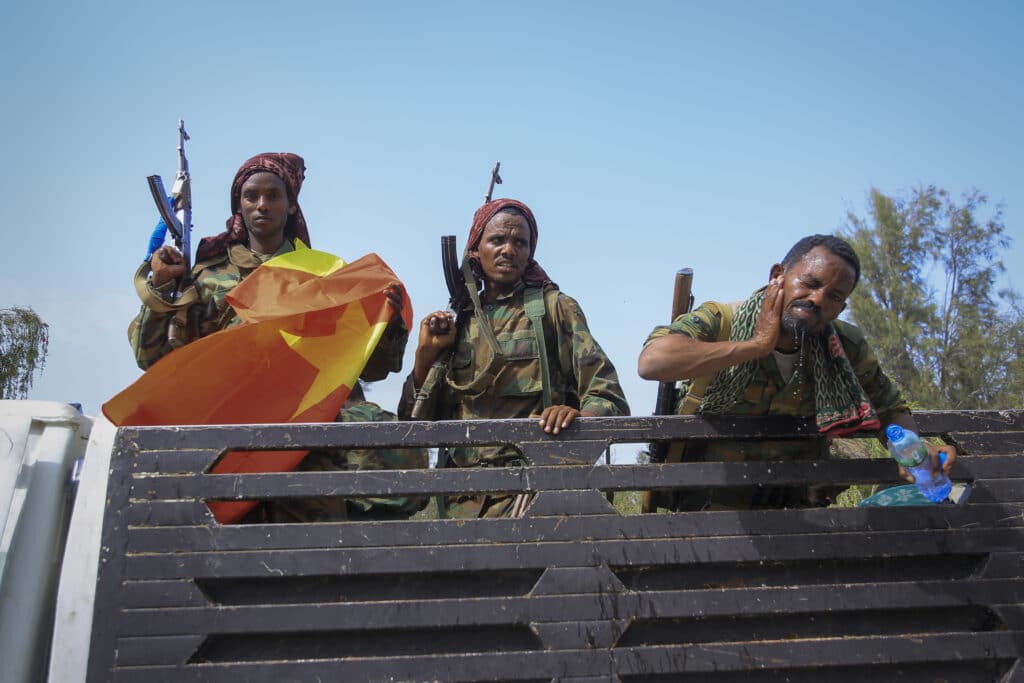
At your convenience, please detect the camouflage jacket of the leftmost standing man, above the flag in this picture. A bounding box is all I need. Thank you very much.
[128,240,295,370]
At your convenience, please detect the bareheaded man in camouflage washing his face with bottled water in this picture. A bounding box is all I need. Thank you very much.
[639,234,956,510]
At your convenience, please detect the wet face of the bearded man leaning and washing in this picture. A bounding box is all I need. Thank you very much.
[772,247,856,341]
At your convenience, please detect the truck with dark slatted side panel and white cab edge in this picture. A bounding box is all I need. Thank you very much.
[0,401,1024,683]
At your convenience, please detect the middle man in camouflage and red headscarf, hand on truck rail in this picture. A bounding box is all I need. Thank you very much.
[398,199,629,517]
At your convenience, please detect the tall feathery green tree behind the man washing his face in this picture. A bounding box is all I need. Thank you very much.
[841,185,1024,409]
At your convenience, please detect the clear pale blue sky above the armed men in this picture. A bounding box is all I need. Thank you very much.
[0,0,1024,440]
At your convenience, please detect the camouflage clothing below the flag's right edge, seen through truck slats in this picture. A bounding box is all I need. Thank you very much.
[246,385,428,522]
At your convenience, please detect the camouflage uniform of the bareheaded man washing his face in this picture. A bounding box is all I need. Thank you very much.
[644,305,909,509]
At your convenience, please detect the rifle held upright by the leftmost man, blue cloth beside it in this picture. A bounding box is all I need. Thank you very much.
[146,119,191,346]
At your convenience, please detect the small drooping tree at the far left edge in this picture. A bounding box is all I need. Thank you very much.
[0,307,49,398]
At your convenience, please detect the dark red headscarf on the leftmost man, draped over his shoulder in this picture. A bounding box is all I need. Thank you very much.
[196,152,309,261]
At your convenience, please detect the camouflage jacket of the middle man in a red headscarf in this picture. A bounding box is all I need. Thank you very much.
[398,285,630,467]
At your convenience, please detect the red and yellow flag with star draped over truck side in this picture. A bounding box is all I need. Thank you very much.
[103,242,412,523]
